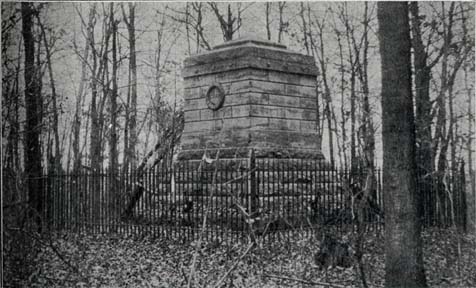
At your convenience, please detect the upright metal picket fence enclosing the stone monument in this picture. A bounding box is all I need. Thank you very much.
[21,158,465,239]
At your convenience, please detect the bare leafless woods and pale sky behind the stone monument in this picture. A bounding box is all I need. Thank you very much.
[2,2,475,227]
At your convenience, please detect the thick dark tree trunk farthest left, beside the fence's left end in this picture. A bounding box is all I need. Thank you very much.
[21,2,43,225]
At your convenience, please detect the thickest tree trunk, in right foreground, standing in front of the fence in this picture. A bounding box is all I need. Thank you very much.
[377,2,427,287]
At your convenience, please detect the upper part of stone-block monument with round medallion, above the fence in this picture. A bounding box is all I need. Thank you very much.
[178,38,323,160]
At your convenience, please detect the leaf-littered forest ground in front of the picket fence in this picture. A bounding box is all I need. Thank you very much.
[7,229,476,287]
